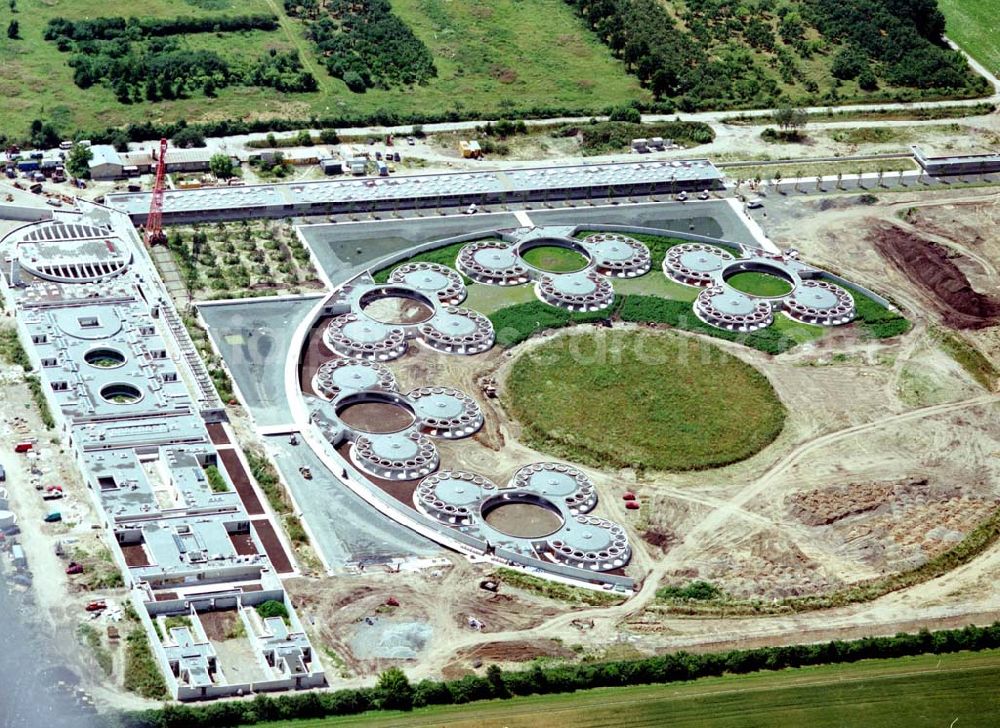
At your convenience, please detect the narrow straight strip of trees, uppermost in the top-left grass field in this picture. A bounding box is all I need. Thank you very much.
[43,14,278,42]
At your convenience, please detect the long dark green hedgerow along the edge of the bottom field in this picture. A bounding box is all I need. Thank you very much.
[113,622,1000,728]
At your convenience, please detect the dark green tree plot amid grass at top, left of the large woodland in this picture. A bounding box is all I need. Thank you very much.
[285,0,437,93]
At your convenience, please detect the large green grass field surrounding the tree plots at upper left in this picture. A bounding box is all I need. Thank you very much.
[0,0,646,136]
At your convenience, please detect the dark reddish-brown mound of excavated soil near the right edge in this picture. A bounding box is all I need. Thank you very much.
[871,225,1000,329]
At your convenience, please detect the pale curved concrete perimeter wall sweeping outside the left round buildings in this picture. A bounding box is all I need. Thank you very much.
[285,284,635,589]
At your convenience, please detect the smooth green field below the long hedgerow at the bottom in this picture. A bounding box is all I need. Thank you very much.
[265,650,1000,728]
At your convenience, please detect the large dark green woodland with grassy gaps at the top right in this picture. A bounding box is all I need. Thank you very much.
[566,0,985,111]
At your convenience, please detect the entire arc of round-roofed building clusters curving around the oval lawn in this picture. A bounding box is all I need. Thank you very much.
[294,222,876,579]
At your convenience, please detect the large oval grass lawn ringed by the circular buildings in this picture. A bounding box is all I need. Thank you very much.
[504,329,785,470]
